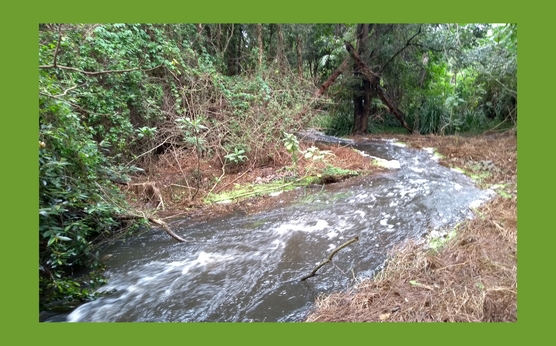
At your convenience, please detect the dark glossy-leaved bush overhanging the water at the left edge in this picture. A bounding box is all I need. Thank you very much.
[39,79,146,304]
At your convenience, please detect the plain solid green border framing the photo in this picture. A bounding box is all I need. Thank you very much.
[8,0,544,346]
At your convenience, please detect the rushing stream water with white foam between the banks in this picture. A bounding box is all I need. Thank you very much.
[67,138,488,322]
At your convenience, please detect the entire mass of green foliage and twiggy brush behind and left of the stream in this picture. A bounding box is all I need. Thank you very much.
[39,24,517,307]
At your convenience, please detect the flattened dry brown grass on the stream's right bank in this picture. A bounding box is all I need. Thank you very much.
[307,132,517,322]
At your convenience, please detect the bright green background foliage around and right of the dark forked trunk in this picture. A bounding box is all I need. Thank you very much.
[312,24,517,135]
